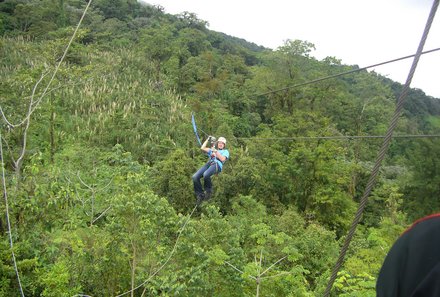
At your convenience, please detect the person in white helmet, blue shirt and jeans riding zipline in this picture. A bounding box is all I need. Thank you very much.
[192,136,229,204]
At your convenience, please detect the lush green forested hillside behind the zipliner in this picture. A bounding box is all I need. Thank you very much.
[0,0,440,297]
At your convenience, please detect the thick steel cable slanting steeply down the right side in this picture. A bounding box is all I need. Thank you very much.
[324,0,440,297]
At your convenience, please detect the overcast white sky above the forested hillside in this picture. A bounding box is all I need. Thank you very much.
[150,0,440,98]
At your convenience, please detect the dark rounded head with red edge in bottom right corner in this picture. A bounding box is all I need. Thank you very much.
[376,213,440,297]
